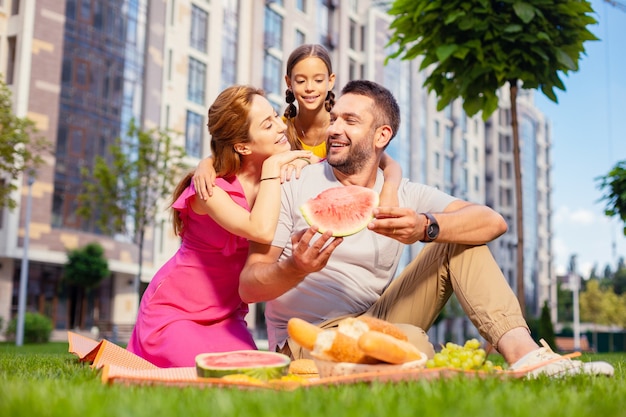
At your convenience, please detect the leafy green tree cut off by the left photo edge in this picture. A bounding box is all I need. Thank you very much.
[0,78,50,209]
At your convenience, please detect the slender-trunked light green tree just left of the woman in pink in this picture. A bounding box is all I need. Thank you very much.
[77,120,187,294]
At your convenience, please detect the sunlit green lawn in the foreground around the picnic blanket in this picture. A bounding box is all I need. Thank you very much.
[0,343,626,417]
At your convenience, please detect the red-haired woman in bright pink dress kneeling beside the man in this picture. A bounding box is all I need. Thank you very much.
[128,86,311,367]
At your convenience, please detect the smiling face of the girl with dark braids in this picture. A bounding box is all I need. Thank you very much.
[285,57,335,110]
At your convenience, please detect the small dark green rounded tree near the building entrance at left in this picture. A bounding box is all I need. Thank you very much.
[63,243,111,328]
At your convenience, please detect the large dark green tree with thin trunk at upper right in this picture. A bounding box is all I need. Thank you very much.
[388,0,597,311]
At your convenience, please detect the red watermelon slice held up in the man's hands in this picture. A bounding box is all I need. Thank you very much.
[300,185,378,236]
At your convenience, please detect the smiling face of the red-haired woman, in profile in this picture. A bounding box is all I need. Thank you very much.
[244,95,291,158]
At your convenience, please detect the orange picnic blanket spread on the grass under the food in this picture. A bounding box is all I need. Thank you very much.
[67,332,580,390]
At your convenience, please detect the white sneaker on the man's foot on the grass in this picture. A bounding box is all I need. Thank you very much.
[509,339,614,378]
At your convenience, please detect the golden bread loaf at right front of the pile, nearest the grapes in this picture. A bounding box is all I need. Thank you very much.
[358,331,423,364]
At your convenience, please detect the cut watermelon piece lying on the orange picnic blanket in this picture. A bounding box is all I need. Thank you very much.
[196,350,291,381]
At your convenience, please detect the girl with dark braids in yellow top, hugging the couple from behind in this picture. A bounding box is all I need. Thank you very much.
[193,44,402,206]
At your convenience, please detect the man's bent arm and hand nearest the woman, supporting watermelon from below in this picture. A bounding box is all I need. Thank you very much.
[239,227,343,303]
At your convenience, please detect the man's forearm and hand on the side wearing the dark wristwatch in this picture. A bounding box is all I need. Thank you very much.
[368,200,508,245]
